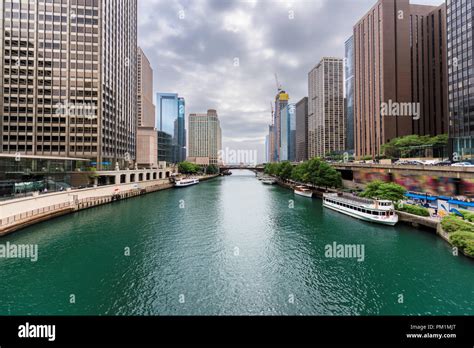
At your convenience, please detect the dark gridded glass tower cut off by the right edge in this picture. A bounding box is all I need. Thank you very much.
[447,0,474,160]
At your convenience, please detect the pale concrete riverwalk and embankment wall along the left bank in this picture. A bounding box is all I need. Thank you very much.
[0,175,218,237]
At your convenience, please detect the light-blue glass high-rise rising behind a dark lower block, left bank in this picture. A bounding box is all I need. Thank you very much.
[156,93,186,163]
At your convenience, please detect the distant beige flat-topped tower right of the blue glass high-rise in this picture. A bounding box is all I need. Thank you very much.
[188,110,222,165]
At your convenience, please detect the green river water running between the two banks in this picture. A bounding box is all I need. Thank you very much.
[0,171,474,315]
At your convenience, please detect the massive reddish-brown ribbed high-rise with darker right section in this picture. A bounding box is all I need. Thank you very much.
[354,0,447,157]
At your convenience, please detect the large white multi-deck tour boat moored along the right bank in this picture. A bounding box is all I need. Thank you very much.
[323,193,398,226]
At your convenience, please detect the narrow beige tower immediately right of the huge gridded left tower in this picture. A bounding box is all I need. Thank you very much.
[137,47,158,168]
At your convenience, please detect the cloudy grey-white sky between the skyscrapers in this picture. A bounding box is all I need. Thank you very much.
[138,0,443,163]
